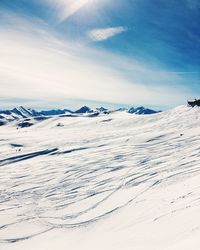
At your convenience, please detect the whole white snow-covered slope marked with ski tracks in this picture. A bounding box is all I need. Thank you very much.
[0,106,200,250]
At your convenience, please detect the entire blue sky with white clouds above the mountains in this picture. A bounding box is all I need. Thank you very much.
[0,0,200,109]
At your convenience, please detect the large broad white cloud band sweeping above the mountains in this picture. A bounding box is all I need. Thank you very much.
[0,11,195,107]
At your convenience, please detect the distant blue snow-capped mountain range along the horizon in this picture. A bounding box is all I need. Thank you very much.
[0,106,161,126]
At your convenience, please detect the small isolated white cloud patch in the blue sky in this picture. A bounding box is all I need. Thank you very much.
[88,26,128,42]
